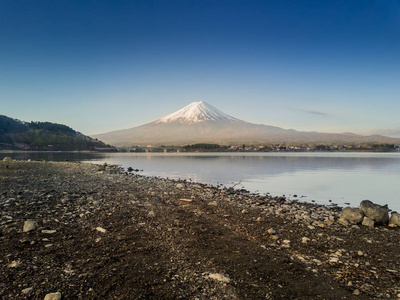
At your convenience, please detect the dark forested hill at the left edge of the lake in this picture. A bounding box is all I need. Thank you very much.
[0,115,111,150]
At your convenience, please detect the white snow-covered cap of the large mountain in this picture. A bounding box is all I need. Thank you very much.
[156,101,239,124]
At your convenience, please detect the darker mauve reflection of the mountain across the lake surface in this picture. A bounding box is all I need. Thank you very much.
[0,152,400,181]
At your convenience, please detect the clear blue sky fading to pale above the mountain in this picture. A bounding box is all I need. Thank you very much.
[0,0,400,137]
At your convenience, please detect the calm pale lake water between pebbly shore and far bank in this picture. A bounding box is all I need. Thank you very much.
[0,153,400,211]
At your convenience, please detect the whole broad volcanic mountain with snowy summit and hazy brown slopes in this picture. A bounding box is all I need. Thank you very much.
[94,101,400,146]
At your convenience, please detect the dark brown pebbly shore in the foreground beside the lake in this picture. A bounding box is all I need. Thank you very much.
[0,160,400,299]
